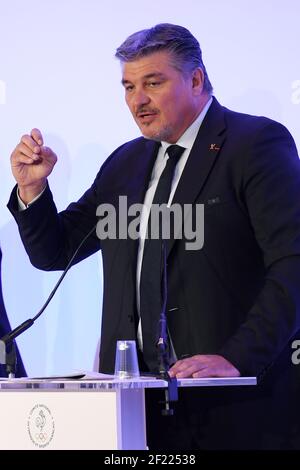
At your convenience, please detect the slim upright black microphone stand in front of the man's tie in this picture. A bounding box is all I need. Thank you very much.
[157,241,178,416]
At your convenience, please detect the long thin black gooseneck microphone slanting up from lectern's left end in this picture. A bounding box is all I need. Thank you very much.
[0,222,98,378]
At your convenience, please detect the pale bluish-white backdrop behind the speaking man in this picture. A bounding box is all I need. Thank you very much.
[0,0,300,375]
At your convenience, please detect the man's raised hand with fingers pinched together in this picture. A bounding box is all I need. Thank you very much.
[10,129,57,204]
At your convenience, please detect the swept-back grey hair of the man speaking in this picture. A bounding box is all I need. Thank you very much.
[115,23,213,95]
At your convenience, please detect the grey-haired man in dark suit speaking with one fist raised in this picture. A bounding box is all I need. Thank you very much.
[8,24,300,449]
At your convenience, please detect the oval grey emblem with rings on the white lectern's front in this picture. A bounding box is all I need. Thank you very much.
[27,405,55,448]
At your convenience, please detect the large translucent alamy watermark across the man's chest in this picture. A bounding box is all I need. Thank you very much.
[96,196,204,250]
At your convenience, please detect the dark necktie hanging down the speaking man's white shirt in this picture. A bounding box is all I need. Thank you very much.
[140,145,185,372]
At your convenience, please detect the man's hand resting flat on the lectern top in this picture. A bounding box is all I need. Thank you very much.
[169,354,241,379]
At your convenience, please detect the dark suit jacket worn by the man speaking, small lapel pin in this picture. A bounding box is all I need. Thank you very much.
[8,99,300,446]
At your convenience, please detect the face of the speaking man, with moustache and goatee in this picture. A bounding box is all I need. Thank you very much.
[122,51,202,143]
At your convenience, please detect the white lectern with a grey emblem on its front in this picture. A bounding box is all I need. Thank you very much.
[0,375,256,450]
